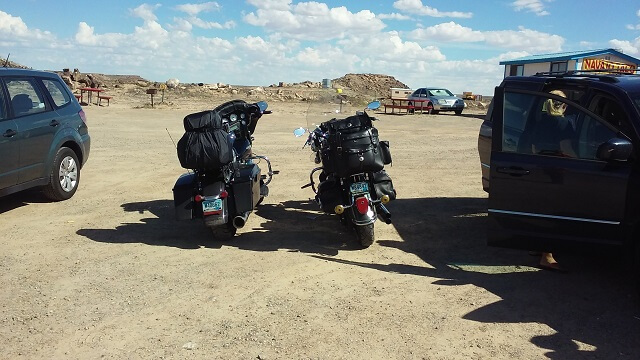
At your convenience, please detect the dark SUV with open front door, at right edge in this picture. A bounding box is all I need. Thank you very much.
[478,72,640,290]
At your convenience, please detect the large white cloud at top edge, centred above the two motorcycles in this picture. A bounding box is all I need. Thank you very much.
[244,0,386,40]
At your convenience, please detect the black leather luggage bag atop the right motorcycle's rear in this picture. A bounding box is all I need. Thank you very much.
[320,115,384,177]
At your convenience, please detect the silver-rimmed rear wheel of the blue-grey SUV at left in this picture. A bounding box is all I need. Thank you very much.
[44,147,80,201]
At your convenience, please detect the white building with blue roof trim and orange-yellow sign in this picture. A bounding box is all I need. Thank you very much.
[500,49,640,77]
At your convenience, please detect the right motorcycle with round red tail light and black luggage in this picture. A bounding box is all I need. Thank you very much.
[294,101,396,248]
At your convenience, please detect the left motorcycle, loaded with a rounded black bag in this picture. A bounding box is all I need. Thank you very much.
[173,100,277,237]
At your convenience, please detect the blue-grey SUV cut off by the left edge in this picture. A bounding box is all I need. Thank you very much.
[0,68,91,201]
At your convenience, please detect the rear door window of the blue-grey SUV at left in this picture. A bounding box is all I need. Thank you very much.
[5,78,46,117]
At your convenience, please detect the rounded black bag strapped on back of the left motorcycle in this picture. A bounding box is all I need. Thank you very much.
[177,110,233,170]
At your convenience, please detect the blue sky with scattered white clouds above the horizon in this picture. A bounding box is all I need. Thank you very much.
[0,0,640,95]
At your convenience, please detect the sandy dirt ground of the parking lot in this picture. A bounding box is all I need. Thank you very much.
[0,96,640,359]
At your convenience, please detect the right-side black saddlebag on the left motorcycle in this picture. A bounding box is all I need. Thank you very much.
[231,164,260,214]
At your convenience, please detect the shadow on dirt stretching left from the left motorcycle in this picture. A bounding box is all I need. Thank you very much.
[76,200,216,249]
